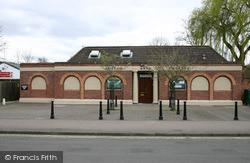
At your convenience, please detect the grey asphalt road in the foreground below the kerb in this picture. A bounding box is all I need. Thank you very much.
[0,134,250,163]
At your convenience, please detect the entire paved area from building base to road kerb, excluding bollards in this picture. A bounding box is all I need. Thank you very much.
[0,102,250,136]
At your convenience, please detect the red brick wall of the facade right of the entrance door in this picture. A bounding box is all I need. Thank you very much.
[159,71,242,100]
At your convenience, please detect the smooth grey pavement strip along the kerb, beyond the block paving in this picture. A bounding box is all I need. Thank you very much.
[0,119,250,136]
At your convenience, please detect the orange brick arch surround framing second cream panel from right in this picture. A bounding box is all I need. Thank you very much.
[188,73,212,100]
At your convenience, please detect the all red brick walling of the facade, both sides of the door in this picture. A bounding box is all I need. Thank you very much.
[20,63,243,100]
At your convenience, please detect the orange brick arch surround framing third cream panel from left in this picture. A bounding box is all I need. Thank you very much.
[81,73,105,99]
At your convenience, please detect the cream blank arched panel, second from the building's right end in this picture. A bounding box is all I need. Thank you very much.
[191,76,208,91]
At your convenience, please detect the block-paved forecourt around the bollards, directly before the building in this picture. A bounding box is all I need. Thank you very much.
[0,102,250,121]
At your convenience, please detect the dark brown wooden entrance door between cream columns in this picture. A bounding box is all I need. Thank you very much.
[139,74,153,103]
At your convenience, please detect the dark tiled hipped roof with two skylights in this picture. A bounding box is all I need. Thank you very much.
[68,46,232,64]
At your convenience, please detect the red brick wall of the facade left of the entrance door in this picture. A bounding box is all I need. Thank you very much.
[21,68,132,100]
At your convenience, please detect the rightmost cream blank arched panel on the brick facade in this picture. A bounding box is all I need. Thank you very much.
[214,76,232,91]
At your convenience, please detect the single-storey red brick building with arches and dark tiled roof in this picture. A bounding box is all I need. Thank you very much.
[20,46,243,104]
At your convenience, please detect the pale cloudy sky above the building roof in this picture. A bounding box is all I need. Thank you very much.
[0,0,236,62]
